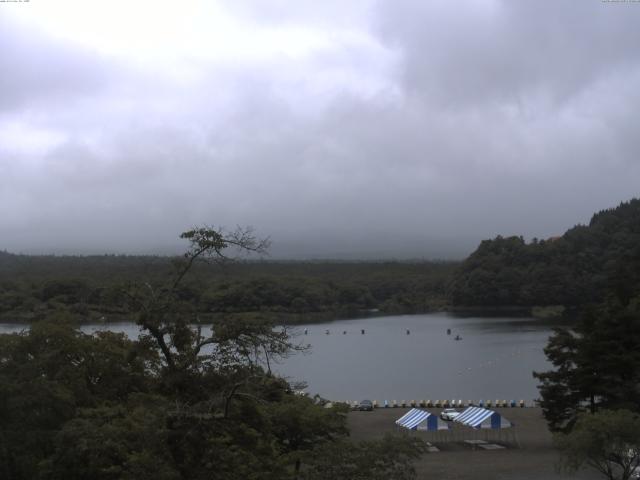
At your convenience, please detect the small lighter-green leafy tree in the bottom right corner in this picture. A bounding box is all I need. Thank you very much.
[555,410,640,480]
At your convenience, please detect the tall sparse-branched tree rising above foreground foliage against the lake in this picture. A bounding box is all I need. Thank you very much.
[120,226,316,419]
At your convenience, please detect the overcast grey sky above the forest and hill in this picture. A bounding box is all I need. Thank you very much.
[0,0,640,258]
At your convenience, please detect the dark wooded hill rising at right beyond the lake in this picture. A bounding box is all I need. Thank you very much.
[450,199,640,307]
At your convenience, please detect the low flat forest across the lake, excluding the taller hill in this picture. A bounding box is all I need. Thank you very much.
[0,253,456,321]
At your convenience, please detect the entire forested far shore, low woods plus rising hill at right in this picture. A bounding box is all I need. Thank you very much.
[0,199,640,323]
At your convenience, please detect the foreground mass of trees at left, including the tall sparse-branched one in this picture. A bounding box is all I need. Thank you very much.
[0,227,421,480]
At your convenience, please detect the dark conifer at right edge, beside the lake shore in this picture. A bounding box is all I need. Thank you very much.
[534,302,640,431]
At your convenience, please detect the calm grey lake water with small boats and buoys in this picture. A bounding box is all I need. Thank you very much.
[0,313,554,401]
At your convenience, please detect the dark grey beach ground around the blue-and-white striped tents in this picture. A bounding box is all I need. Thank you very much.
[348,408,602,480]
